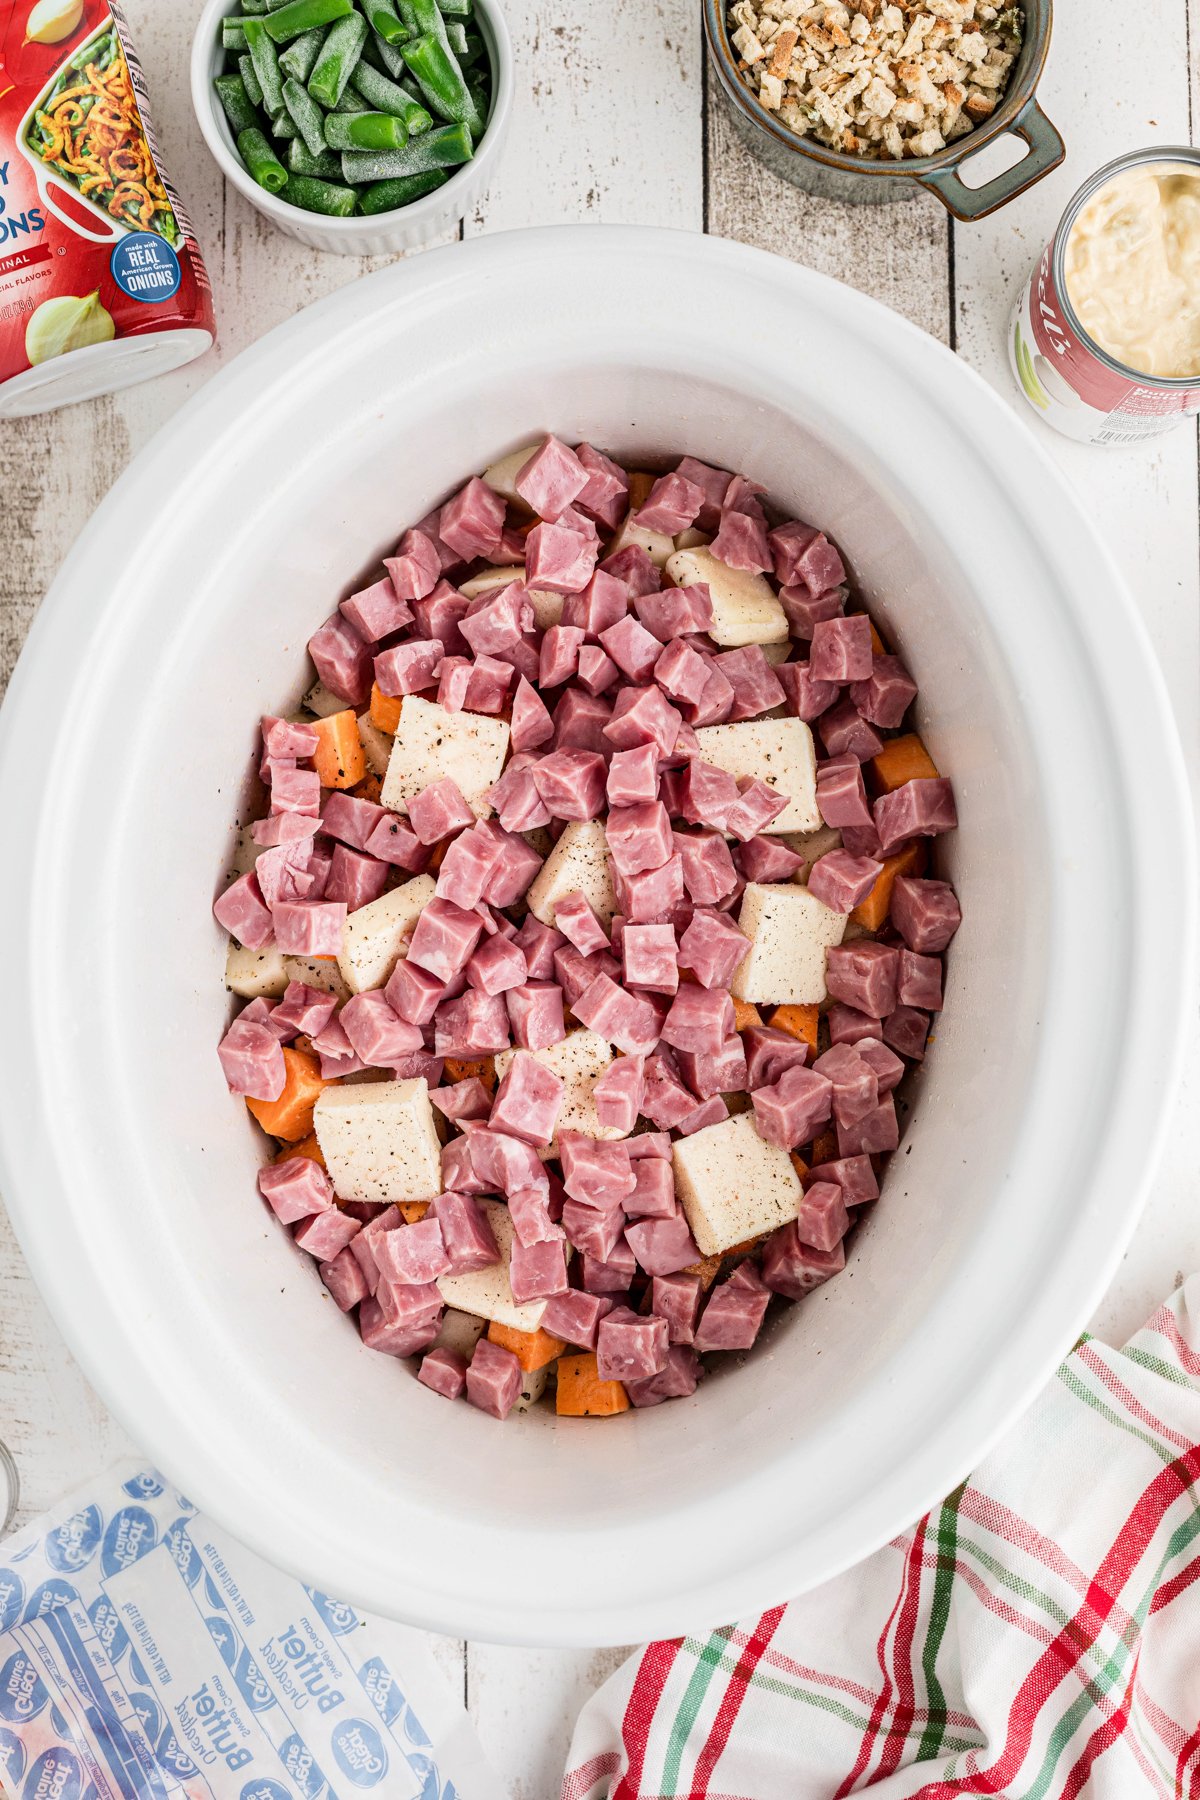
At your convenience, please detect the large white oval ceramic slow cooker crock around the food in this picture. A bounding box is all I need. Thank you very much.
[0,227,1195,1643]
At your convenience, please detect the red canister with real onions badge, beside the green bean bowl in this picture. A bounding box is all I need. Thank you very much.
[0,0,214,418]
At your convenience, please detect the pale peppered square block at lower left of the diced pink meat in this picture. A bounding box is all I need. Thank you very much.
[313,1076,441,1201]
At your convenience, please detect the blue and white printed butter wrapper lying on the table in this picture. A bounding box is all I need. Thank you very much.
[0,1463,502,1800]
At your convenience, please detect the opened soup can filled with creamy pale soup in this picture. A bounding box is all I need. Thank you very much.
[1007,146,1200,445]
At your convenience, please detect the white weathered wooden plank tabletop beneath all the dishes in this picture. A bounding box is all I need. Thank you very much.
[0,0,1200,1800]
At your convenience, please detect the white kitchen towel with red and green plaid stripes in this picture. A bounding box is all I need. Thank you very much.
[561,1276,1200,1800]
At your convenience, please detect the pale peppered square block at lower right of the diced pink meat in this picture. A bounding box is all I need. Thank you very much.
[671,1112,802,1256]
